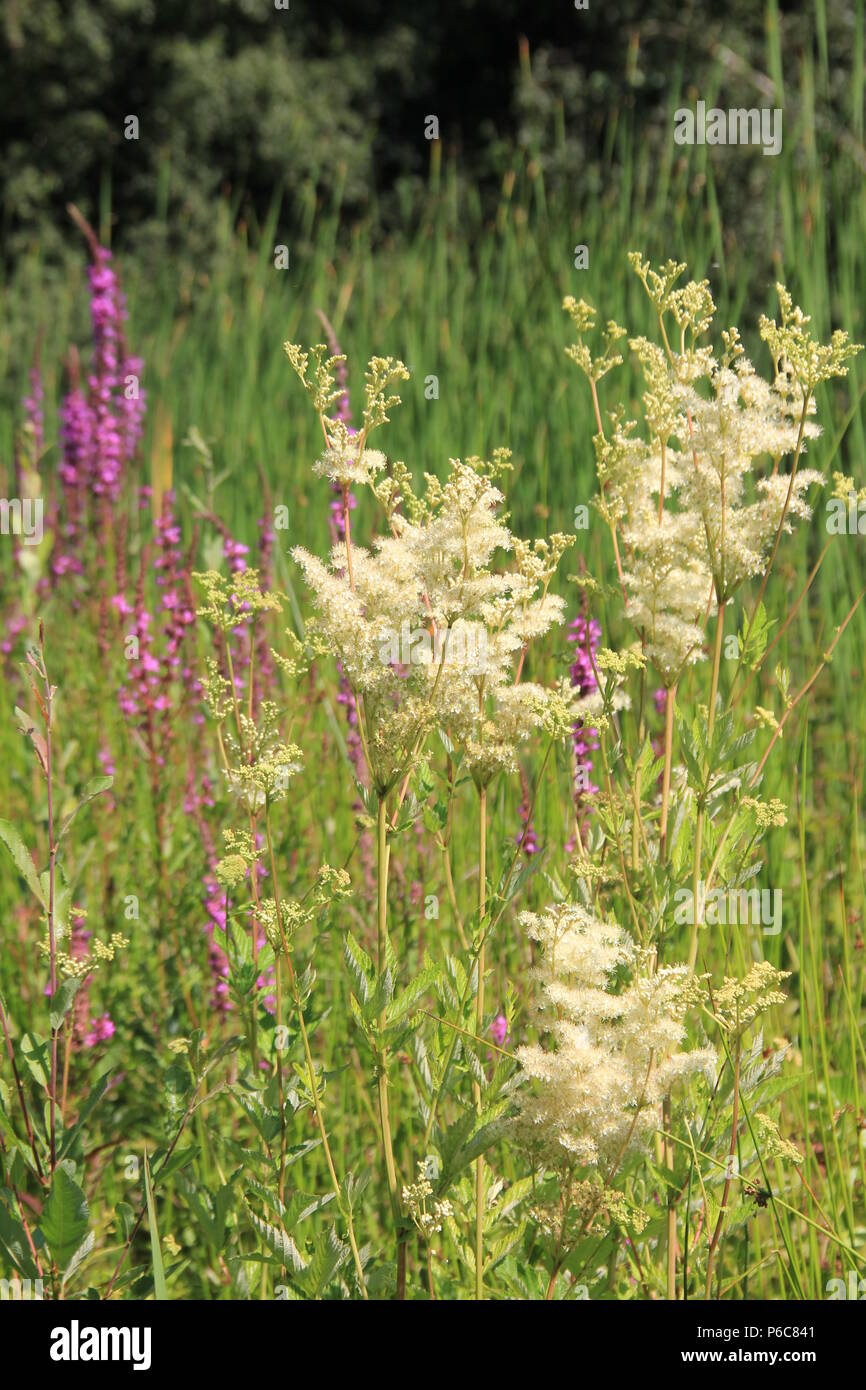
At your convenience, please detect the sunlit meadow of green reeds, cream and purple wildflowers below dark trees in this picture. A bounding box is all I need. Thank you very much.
[0,2,866,1301]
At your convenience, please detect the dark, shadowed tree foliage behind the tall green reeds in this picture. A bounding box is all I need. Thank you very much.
[0,0,847,261]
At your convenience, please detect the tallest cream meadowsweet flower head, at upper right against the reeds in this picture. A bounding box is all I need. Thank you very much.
[563,252,859,688]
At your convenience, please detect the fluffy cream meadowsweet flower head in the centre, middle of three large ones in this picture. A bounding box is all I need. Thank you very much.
[286,345,575,794]
